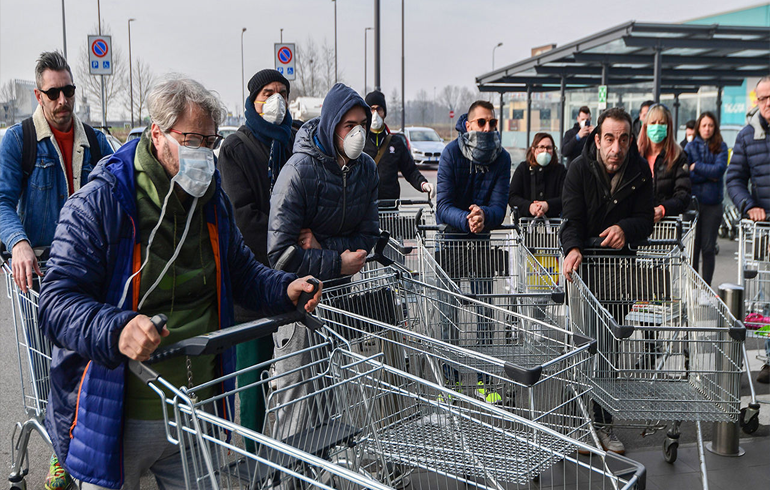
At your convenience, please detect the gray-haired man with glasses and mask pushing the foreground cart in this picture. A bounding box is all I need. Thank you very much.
[40,78,320,490]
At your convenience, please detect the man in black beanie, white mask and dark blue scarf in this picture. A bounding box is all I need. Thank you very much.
[218,69,293,450]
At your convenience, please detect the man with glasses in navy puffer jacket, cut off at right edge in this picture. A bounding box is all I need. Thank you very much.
[724,75,770,383]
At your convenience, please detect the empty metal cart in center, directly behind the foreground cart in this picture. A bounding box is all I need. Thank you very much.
[317,268,594,441]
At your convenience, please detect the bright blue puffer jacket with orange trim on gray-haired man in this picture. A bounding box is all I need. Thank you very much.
[40,139,294,488]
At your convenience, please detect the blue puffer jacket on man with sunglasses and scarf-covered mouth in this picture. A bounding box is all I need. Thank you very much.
[436,114,511,233]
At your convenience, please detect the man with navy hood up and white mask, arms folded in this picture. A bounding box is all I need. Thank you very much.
[267,83,380,439]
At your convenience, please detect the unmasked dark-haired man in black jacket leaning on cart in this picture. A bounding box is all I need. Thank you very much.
[560,107,662,454]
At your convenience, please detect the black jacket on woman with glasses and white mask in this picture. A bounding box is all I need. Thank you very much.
[508,162,567,218]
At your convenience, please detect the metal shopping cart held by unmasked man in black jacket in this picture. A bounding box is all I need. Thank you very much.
[568,251,758,482]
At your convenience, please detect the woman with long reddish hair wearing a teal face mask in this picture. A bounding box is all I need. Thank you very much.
[638,104,692,223]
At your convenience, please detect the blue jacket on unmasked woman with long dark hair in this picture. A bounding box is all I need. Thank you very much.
[685,136,727,205]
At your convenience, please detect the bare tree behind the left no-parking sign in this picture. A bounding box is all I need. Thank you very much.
[74,22,128,122]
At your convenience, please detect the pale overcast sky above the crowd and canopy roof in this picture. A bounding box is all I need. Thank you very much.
[0,0,759,117]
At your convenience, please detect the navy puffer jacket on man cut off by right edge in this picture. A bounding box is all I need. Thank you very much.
[724,111,770,210]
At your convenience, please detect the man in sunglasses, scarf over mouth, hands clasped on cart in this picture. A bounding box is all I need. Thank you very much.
[436,100,511,403]
